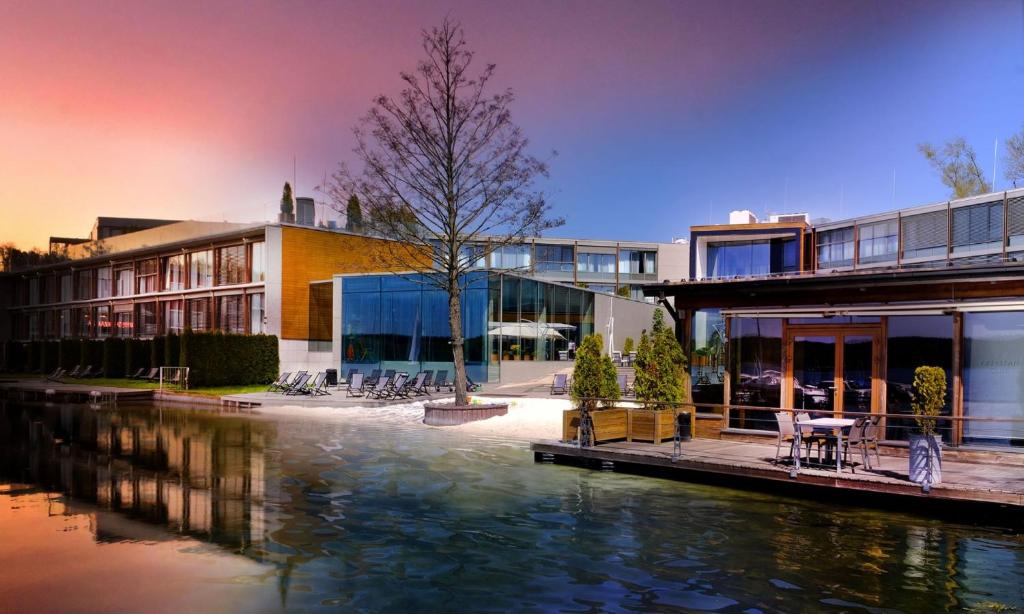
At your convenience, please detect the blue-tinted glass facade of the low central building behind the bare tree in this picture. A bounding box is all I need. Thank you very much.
[341,271,594,382]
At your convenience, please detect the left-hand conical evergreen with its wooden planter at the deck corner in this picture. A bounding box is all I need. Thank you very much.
[562,334,628,445]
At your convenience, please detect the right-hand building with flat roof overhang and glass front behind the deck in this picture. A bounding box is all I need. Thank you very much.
[644,184,1024,448]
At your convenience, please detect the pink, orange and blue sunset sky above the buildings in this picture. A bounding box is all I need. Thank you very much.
[0,0,1024,248]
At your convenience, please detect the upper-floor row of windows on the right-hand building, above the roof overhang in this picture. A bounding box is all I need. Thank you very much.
[817,196,1024,268]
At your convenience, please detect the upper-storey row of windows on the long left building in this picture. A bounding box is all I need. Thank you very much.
[14,242,266,305]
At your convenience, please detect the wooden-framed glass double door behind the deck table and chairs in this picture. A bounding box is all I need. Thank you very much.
[782,324,883,415]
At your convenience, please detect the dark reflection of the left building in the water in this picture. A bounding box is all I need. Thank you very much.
[0,401,275,551]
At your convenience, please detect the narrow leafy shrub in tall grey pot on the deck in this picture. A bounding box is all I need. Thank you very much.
[909,366,946,485]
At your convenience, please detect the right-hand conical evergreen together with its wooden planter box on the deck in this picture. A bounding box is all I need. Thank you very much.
[629,309,688,443]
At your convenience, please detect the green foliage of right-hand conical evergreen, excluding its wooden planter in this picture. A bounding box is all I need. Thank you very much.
[634,309,687,408]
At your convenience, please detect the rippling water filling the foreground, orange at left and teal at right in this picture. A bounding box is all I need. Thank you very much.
[0,401,1024,612]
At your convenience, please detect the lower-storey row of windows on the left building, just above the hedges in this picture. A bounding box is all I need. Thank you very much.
[13,294,265,339]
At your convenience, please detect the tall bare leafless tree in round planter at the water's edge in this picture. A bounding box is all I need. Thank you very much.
[324,19,563,404]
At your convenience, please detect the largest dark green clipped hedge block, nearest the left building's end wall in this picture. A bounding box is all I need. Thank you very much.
[180,331,279,386]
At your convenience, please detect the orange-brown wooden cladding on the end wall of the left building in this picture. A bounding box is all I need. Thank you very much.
[281,226,423,340]
